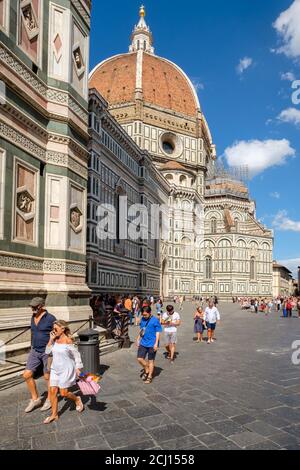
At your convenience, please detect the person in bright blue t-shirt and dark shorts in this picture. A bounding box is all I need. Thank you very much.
[136,307,162,384]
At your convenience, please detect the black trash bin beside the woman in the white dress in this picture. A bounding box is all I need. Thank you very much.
[78,329,100,374]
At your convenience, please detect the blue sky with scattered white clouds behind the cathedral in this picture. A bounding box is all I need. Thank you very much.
[90,0,300,278]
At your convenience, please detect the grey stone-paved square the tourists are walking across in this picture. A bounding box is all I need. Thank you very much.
[0,303,300,450]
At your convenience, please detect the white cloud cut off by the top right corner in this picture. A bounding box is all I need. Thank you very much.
[273,0,300,59]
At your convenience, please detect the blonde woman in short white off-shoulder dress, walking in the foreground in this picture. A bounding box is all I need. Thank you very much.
[44,320,84,424]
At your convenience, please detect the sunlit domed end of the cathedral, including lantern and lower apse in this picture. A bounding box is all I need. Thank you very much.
[89,7,273,300]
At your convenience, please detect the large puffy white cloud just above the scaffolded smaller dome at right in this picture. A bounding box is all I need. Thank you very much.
[224,139,296,177]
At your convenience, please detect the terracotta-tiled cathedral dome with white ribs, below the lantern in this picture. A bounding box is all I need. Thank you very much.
[89,51,200,117]
